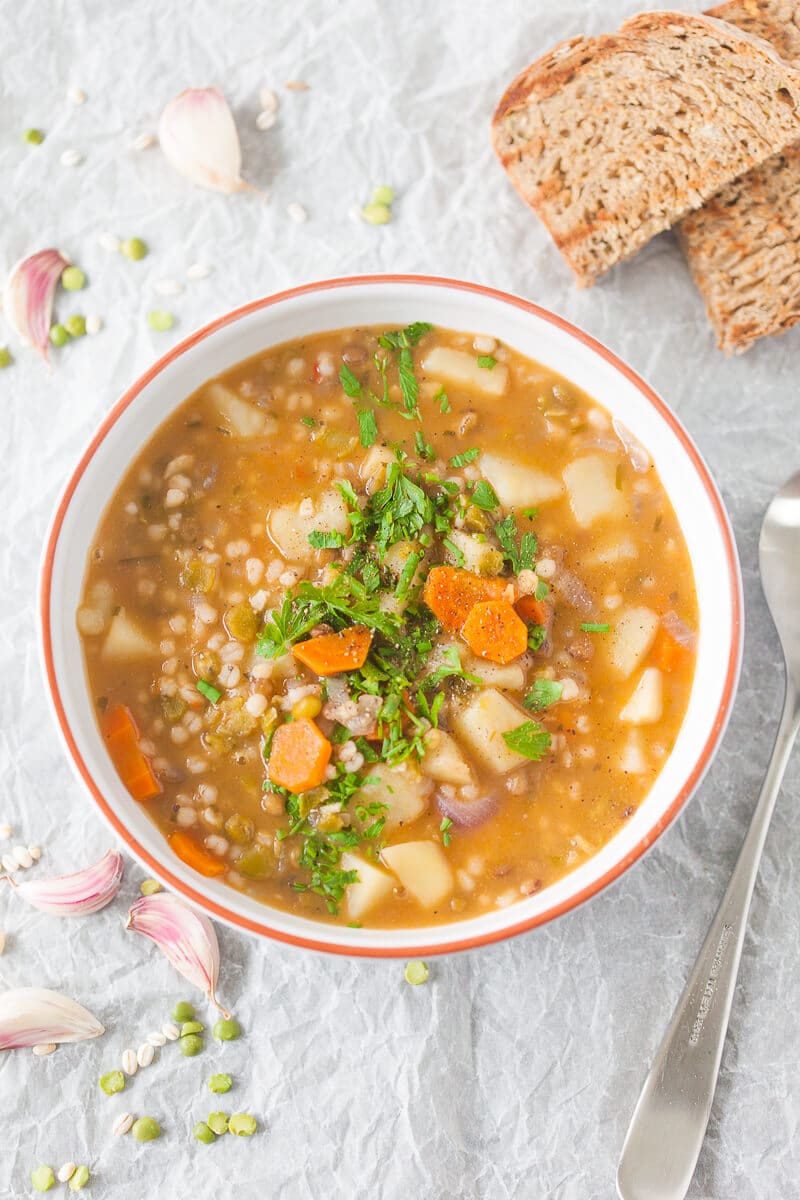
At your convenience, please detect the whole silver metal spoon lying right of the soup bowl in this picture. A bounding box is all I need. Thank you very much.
[616,473,800,1200]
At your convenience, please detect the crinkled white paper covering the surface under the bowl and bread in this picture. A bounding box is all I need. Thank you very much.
[0,0,800,1200]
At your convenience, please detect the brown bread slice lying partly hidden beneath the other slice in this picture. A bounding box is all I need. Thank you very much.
[678,0,800,354]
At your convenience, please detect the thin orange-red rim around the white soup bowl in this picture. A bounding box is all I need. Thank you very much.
[40,275,742,959]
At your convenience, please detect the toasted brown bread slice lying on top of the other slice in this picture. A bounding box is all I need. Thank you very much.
[492,12,800,286]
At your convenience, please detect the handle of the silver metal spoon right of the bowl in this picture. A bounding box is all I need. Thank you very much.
[616,684,800,1200]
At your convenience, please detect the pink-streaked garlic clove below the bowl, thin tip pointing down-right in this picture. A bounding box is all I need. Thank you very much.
[126,892,230,1016]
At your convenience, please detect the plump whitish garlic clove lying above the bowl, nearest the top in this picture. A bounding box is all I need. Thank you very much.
[158,88,255,194]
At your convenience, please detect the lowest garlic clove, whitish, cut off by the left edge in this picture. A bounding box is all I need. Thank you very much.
[0,988,106,1050]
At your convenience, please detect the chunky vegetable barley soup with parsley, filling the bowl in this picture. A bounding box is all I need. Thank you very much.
[77,323,698,928]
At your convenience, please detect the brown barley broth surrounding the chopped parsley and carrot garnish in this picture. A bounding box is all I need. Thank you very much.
[78,329,698,928]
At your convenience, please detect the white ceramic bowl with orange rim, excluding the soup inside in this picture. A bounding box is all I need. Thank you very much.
[41,276,742,958]
